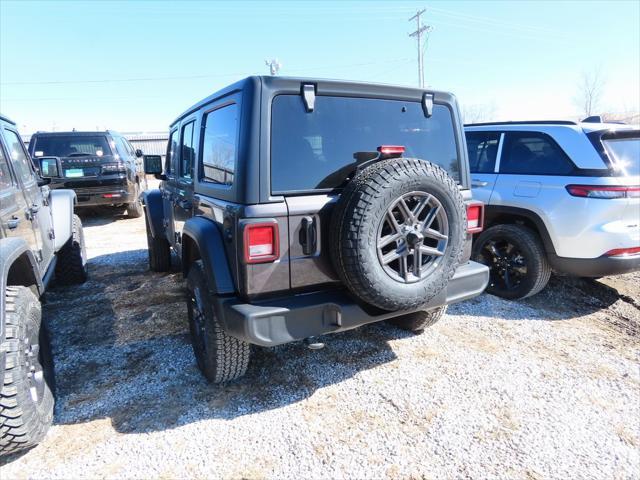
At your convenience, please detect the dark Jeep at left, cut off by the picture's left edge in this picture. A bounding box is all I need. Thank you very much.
[0,116,87,456]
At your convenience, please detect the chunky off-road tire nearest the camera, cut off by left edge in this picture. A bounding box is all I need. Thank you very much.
[0,286,54,455]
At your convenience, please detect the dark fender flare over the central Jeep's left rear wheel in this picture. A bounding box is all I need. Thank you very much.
[182,217,236,295]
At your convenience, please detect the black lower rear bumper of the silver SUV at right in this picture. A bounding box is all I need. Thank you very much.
[549,251,640,277]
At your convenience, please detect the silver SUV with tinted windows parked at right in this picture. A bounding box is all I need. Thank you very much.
[465,117,640,298]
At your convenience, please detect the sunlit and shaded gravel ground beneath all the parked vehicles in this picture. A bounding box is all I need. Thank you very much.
[0,208,640,480]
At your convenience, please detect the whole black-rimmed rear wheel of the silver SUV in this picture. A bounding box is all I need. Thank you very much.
[472,225,551,300]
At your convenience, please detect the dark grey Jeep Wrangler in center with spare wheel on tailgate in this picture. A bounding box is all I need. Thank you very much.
[143,77,489,382]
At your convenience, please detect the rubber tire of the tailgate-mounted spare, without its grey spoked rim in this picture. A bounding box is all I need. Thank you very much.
[330,158,466,311]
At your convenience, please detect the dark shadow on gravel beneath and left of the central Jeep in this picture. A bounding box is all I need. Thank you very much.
[45,250,409,433]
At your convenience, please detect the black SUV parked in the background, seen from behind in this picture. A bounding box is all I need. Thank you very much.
[29,130,146,218]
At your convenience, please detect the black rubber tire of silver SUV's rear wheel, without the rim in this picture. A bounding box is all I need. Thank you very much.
[471,224,551,300]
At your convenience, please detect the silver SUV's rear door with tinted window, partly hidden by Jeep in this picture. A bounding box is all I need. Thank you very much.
[466,132,504,205]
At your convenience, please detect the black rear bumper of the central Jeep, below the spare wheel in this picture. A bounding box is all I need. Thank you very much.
[217,262,489,347]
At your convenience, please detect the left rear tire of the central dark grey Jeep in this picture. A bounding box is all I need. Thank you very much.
[187,260,251,383]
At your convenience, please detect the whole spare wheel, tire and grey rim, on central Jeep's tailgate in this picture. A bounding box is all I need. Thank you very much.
[331,158,466,311]
